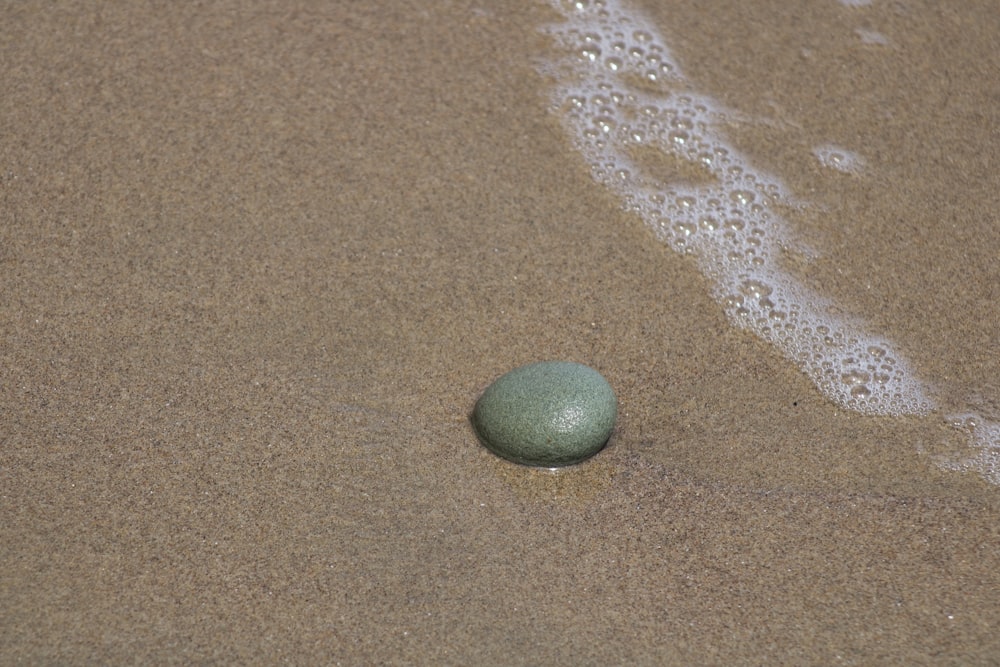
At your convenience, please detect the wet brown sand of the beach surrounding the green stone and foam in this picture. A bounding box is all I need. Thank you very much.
[0,0,1000,665]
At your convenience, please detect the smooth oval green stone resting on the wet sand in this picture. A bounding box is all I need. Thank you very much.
[472,361,618,468]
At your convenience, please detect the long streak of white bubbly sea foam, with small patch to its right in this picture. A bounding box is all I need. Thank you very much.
[543,0,932,415]
